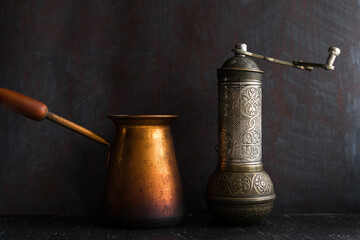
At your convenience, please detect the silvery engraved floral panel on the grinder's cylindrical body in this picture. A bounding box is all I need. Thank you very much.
[219,85,261,163]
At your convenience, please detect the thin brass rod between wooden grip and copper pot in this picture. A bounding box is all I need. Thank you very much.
[46,112,111,147]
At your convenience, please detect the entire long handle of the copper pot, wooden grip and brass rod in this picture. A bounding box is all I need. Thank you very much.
[0,88,111,147]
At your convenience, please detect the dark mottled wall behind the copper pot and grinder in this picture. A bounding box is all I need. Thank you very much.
[0,0,360,215]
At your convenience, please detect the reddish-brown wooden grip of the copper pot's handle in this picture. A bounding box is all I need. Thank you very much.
[0,88,48,121]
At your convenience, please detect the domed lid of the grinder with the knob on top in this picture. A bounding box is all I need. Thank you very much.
[218,44,264,73]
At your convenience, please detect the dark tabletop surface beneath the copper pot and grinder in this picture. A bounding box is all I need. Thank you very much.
[0,214,360,240]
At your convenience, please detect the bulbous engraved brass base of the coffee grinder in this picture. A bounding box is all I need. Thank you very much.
[206,164,276,225]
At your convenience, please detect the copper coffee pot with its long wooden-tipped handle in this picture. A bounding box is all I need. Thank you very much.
[0,88,185,227]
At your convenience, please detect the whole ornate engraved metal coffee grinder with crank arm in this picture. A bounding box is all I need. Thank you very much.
[206,43,340,225]
